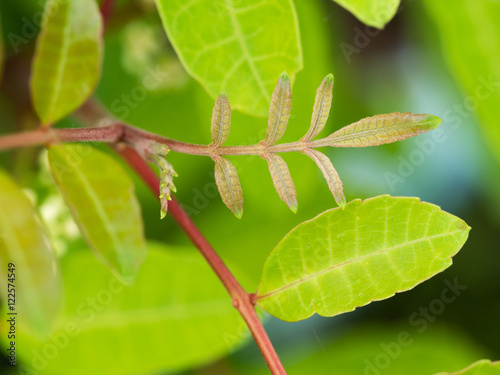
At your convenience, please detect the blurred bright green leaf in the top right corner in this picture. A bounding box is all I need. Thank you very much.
[423,0,500,162]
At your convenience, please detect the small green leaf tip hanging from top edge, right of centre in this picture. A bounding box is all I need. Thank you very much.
[334,0,400,29]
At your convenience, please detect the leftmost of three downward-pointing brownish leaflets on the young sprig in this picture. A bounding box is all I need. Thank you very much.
[213,156,243,219]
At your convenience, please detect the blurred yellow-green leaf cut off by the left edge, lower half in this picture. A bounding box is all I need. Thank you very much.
[0,170,62,336]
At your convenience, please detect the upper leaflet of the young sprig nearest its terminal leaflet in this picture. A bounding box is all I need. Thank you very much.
[302,74,333,142]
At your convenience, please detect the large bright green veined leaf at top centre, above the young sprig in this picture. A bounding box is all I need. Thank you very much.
[156,0,302,116]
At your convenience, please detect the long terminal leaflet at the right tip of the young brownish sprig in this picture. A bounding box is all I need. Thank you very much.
[326,112,441,147]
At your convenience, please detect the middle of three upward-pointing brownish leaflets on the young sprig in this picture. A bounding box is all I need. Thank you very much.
[261,73,292,146]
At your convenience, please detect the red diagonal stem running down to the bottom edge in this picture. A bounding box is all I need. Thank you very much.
[115,146,286,375]
